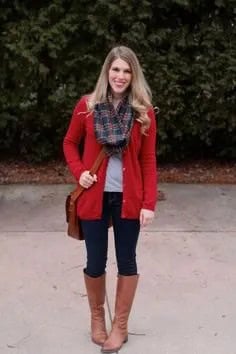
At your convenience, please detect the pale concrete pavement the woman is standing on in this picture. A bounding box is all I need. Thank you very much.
[0,184,236,354]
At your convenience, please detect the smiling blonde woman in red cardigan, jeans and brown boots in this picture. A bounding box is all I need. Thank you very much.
[64,46,157,353]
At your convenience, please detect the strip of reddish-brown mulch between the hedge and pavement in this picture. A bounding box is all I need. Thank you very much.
[0,160,236,184]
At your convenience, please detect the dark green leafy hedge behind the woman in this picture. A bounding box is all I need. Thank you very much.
[0,0,236,162]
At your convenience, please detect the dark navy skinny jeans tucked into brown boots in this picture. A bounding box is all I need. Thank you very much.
[81,192,140,277]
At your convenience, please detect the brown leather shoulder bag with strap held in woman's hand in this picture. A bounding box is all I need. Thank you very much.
[65,148,105,240]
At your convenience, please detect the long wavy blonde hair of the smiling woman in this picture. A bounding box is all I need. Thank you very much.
[88,46,152,134]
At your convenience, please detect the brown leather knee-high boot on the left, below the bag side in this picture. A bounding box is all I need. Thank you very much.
[84,273,107,345]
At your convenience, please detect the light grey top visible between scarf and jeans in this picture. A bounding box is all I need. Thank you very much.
[104,154,123,192]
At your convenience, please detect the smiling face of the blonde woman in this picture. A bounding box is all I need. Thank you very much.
[108,58,132,98]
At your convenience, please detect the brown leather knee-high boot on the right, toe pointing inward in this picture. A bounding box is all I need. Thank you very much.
[101,275,139,353]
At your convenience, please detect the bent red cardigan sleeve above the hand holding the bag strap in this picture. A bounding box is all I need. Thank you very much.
[63,97,87,181]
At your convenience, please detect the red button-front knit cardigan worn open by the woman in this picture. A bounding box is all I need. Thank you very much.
[63,96,157,220]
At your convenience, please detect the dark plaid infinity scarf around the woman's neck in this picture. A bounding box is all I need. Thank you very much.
[94,97,134,155]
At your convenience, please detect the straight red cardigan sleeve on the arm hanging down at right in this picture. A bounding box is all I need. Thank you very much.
[140,109,157,210]
